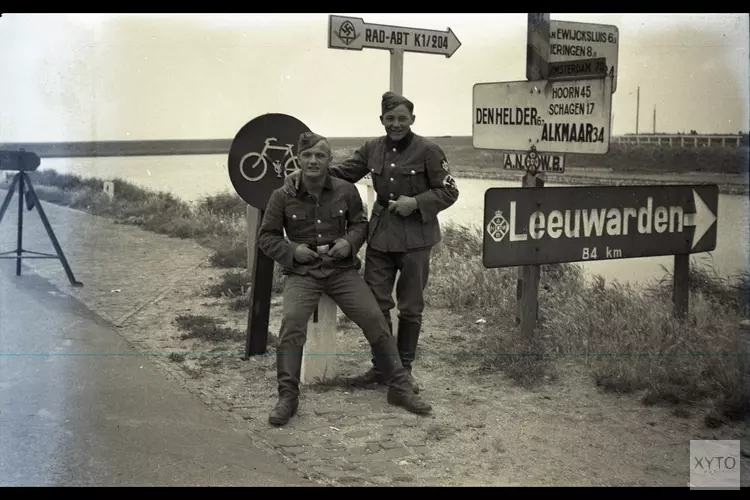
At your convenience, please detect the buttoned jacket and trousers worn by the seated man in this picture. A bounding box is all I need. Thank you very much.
[258,176,390,352]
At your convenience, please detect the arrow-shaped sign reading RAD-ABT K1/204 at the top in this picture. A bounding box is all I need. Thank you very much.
[328,16,461,57]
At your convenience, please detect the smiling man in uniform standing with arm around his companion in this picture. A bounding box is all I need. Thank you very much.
[284,92,458,392]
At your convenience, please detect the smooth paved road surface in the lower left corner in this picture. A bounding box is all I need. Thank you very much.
[0,260,311,486]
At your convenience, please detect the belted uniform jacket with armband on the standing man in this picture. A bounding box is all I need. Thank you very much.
[329,132,458,252]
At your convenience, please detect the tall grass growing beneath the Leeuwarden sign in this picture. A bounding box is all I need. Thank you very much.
[427,219,750,425]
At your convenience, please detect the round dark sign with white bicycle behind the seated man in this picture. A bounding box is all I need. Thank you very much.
[227,113,310,210]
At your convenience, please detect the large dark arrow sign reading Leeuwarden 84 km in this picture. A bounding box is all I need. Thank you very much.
[482,184,719,268]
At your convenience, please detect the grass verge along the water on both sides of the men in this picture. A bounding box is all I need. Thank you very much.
[0,171,750,427]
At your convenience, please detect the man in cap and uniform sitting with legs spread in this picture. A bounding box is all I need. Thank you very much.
[258,132,431,425]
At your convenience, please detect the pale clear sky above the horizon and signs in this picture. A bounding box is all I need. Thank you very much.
[0,12,750,142]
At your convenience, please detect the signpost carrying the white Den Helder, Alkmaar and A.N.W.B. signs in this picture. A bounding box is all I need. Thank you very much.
[472,13,617,338]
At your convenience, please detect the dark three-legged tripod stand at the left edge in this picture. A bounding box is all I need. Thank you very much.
[0,170,83,287]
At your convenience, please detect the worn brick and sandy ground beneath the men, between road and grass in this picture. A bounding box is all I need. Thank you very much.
[0,179,742,486]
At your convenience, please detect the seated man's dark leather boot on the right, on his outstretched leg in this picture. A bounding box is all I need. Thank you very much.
[372,336,432,415]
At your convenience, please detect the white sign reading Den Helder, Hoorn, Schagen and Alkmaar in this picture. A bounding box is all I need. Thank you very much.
[472,78,612,154]
